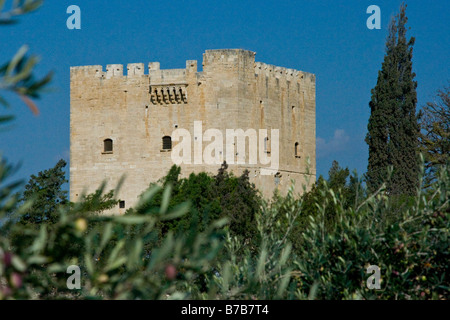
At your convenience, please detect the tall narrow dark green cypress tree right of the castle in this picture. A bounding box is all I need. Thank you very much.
[366,4,419,195]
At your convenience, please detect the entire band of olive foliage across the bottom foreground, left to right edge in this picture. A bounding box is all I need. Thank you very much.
[0,158,450,299]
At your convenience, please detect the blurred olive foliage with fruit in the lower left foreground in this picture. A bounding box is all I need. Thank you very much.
[0,161,225,299]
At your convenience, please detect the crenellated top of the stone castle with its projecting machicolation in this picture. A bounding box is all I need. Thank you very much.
[70,49,315,110]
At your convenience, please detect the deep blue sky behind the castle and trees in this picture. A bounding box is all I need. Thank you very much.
[0,0,450,189]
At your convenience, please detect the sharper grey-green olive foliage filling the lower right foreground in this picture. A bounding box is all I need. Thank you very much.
[209,167,450,299]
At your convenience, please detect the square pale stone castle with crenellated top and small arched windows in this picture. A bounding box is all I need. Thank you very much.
[70,49,316,213]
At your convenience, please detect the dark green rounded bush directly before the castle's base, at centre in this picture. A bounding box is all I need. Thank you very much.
[129,163,261,239]
